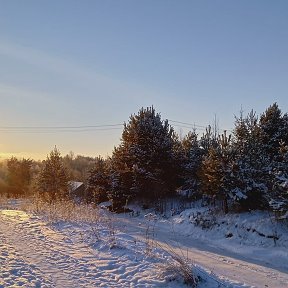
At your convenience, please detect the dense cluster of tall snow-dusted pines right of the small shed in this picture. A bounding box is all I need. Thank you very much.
[87,103,288,218]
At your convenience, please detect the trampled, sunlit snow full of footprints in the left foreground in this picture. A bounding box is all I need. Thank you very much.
[0,210,181,288]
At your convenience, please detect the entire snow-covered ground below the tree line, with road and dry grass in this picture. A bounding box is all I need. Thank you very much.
[0,200,288,288]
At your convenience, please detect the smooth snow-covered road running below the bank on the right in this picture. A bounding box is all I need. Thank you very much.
[117,216,288,288]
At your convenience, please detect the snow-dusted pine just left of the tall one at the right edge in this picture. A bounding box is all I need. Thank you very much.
[232,110,270,210]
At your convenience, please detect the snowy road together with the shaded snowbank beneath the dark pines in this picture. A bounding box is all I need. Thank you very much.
[119,206,288,288]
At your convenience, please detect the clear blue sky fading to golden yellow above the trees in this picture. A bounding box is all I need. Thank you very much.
[0,0,288,160]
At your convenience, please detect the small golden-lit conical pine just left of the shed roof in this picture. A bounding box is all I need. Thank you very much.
[37,146,69,202]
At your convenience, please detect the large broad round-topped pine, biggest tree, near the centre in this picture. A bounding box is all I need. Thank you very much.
[112,107,177,206]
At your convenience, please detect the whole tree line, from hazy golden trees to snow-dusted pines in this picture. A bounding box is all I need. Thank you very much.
[0,103,288,215]
